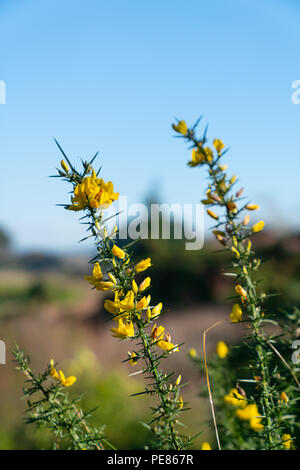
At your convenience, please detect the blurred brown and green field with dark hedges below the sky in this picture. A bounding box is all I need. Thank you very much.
[0,229,300,449]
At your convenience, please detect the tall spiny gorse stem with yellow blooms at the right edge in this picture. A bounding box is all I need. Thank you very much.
[173,115,299,449]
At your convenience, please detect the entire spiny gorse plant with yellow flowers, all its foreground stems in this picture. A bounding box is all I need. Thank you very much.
[14,115,300,450]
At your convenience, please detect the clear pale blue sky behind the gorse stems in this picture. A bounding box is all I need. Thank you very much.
[0,0,300,251]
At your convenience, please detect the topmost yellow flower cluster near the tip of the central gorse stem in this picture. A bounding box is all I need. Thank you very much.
[68,171,119,211]
